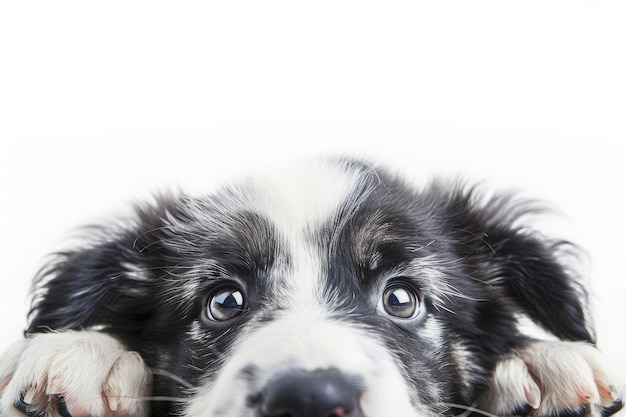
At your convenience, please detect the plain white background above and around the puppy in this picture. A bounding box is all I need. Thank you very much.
[0,0,626,400]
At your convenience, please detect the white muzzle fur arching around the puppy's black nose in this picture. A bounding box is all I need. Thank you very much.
[186,309,432,417]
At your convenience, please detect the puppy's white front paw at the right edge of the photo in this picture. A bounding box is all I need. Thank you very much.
[479,341,622,417]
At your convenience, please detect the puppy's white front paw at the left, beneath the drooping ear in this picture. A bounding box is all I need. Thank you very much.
[0,331,152,417]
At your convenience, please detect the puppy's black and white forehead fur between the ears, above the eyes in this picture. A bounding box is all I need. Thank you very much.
[148,160,456,304]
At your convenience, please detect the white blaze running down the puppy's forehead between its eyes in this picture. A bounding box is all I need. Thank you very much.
[241,160,371,306]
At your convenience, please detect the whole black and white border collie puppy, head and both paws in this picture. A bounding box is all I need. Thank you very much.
[0,160,622,417]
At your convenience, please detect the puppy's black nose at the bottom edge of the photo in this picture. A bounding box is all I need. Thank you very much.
[259,368,362,417]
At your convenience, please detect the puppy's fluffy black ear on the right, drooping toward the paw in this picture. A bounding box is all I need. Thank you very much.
[436,190,594,343]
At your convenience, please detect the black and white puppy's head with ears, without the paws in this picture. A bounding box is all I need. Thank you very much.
[29,161,591,417]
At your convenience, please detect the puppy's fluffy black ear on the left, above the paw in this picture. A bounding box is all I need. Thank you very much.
[26,198,175,336]
